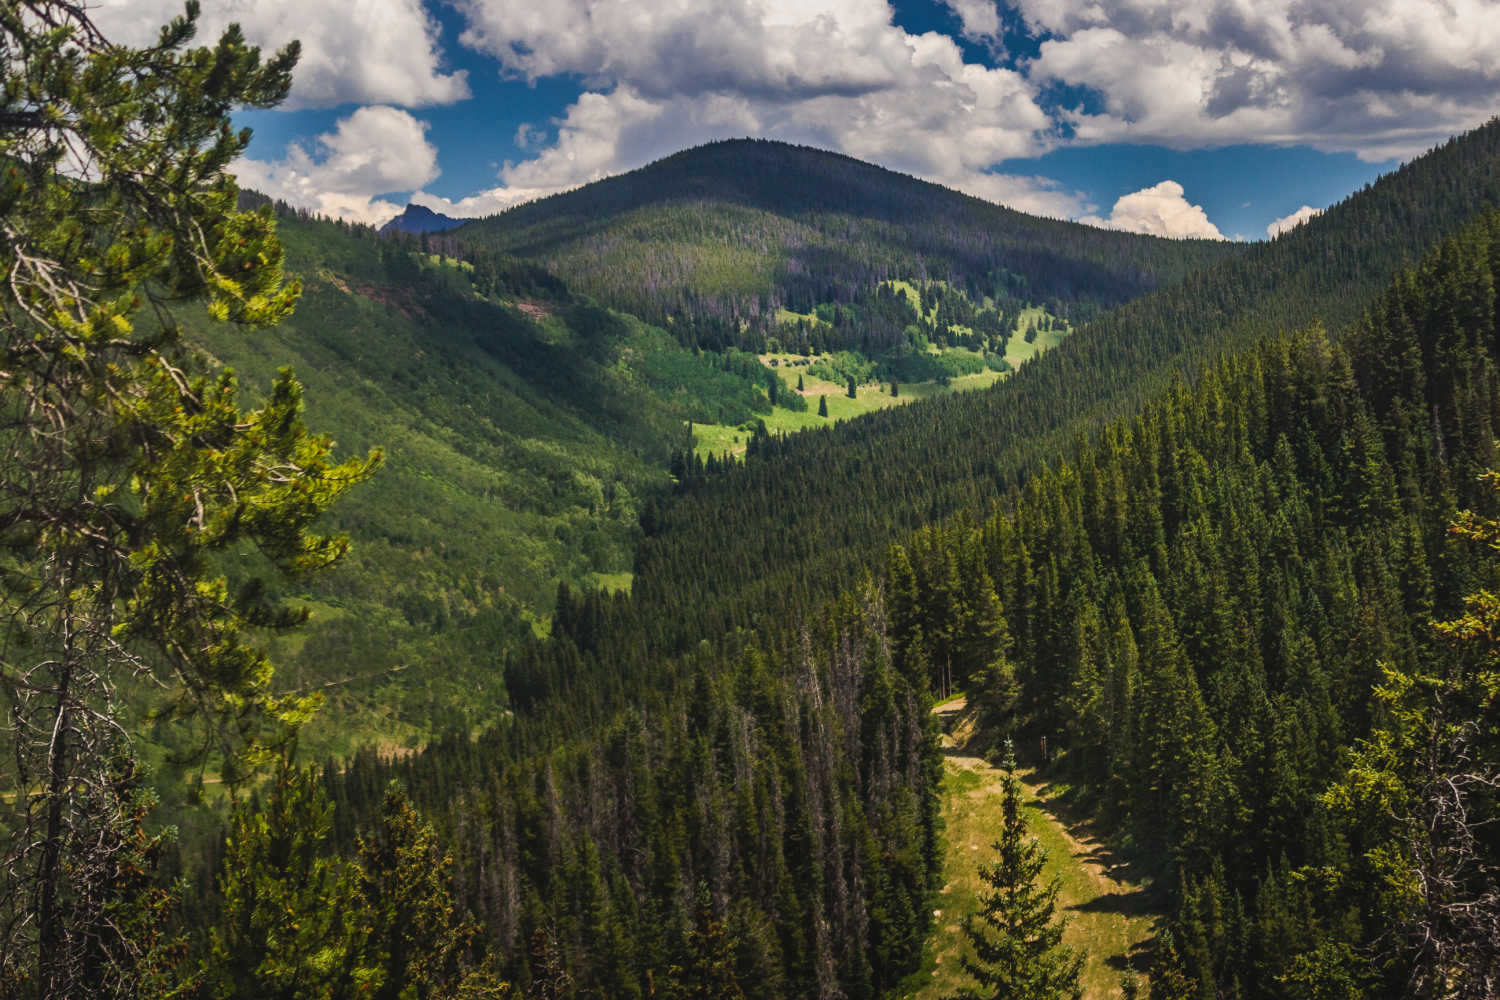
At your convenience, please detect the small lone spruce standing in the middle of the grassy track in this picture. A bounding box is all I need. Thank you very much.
[960,741,1083,1000]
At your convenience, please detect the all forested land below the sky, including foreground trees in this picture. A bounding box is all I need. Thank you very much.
[0,0,1500,1000]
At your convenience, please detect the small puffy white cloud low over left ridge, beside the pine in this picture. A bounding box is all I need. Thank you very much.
[231,106,438,225]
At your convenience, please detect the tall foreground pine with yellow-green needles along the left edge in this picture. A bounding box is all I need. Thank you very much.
[0,0,378,1000]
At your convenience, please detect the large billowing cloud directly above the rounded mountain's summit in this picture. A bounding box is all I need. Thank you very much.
[438,0,1088,216]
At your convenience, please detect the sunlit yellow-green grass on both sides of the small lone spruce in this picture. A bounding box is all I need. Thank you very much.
[906,760,1152,1000]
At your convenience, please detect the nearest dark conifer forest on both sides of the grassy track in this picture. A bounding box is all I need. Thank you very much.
[190,176,1500,1000]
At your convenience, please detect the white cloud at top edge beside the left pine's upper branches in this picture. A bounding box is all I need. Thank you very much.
[92,0,470,108]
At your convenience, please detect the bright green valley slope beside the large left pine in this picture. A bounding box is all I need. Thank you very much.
[186,211,771,750]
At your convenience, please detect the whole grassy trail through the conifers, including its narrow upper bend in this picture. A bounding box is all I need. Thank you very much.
[912,697,1152,1000]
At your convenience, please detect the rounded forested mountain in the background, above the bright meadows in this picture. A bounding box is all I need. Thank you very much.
[450,139,1241,340]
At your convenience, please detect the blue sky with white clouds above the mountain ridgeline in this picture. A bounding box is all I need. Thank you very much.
[93,0,1500,240]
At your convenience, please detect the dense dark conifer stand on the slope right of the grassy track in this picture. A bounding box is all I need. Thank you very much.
[885,213,1500,1000]
